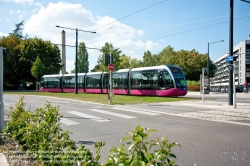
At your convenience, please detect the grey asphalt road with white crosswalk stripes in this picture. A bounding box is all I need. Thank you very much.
[4,92,250,166]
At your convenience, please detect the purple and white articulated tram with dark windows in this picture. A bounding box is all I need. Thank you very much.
[40,65,188,96]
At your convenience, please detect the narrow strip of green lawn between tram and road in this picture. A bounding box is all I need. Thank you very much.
[4,92,190,105]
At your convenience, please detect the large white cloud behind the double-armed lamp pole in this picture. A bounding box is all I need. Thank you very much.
[23,2,158,72]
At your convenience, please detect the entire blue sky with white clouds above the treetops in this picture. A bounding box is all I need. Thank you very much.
[0,0,250,72]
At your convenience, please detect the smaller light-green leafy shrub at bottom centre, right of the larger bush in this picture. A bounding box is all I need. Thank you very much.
[106,126,180,166]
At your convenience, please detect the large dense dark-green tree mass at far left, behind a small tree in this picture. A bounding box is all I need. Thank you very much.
[0,34,61,88]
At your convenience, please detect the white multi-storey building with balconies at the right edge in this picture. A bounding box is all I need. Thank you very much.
[210,35,250,92]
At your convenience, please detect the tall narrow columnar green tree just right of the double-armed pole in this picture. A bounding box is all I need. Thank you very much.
[78,42,89,73]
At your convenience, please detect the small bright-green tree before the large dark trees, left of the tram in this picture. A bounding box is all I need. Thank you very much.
[31,57,45,82]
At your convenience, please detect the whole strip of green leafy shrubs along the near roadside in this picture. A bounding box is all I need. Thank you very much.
[0,97,180,166]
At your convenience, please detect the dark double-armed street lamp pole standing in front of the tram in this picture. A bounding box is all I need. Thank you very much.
[56,25,96,94]
